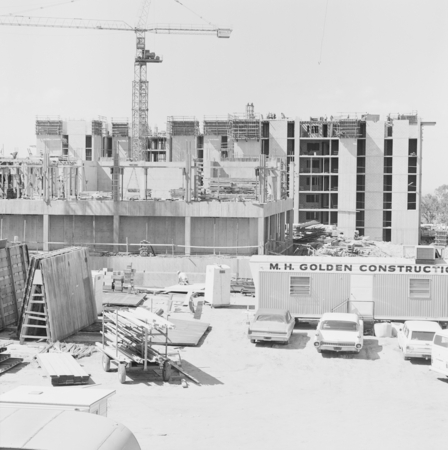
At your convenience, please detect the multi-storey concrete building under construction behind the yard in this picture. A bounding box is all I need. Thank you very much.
[0,104,432,255]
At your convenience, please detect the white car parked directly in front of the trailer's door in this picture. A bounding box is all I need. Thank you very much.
[314,313,364,353]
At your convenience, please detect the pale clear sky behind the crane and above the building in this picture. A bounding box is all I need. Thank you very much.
[0,0,448,194]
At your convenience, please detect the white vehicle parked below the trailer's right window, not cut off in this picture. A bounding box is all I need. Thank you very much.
[397,320,442,360]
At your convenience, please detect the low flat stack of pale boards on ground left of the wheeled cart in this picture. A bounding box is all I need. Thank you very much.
[37,353,90,386]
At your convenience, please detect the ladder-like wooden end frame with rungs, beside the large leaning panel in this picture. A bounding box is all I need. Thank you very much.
[20,270,50,344]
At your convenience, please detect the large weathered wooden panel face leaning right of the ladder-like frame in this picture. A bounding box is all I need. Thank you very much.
[40,248,97,341]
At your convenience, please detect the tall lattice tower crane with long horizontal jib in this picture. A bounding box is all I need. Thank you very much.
[0,0,232,161]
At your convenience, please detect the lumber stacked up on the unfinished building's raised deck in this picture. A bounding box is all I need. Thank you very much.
[208,178,258,200]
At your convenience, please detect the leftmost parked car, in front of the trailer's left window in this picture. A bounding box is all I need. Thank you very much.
[247,309,295,344]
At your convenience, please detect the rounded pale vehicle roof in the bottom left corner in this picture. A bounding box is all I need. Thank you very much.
[0,405,141,450]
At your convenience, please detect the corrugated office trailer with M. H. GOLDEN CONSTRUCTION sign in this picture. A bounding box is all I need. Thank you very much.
[250,255,448,324]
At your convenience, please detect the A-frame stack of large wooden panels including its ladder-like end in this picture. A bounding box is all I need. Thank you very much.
[18,247,97,343]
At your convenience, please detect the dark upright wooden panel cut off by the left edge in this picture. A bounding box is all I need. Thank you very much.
[0,244,29,330]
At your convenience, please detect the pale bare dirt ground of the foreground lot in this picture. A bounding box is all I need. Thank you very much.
[0,298,448,450]
